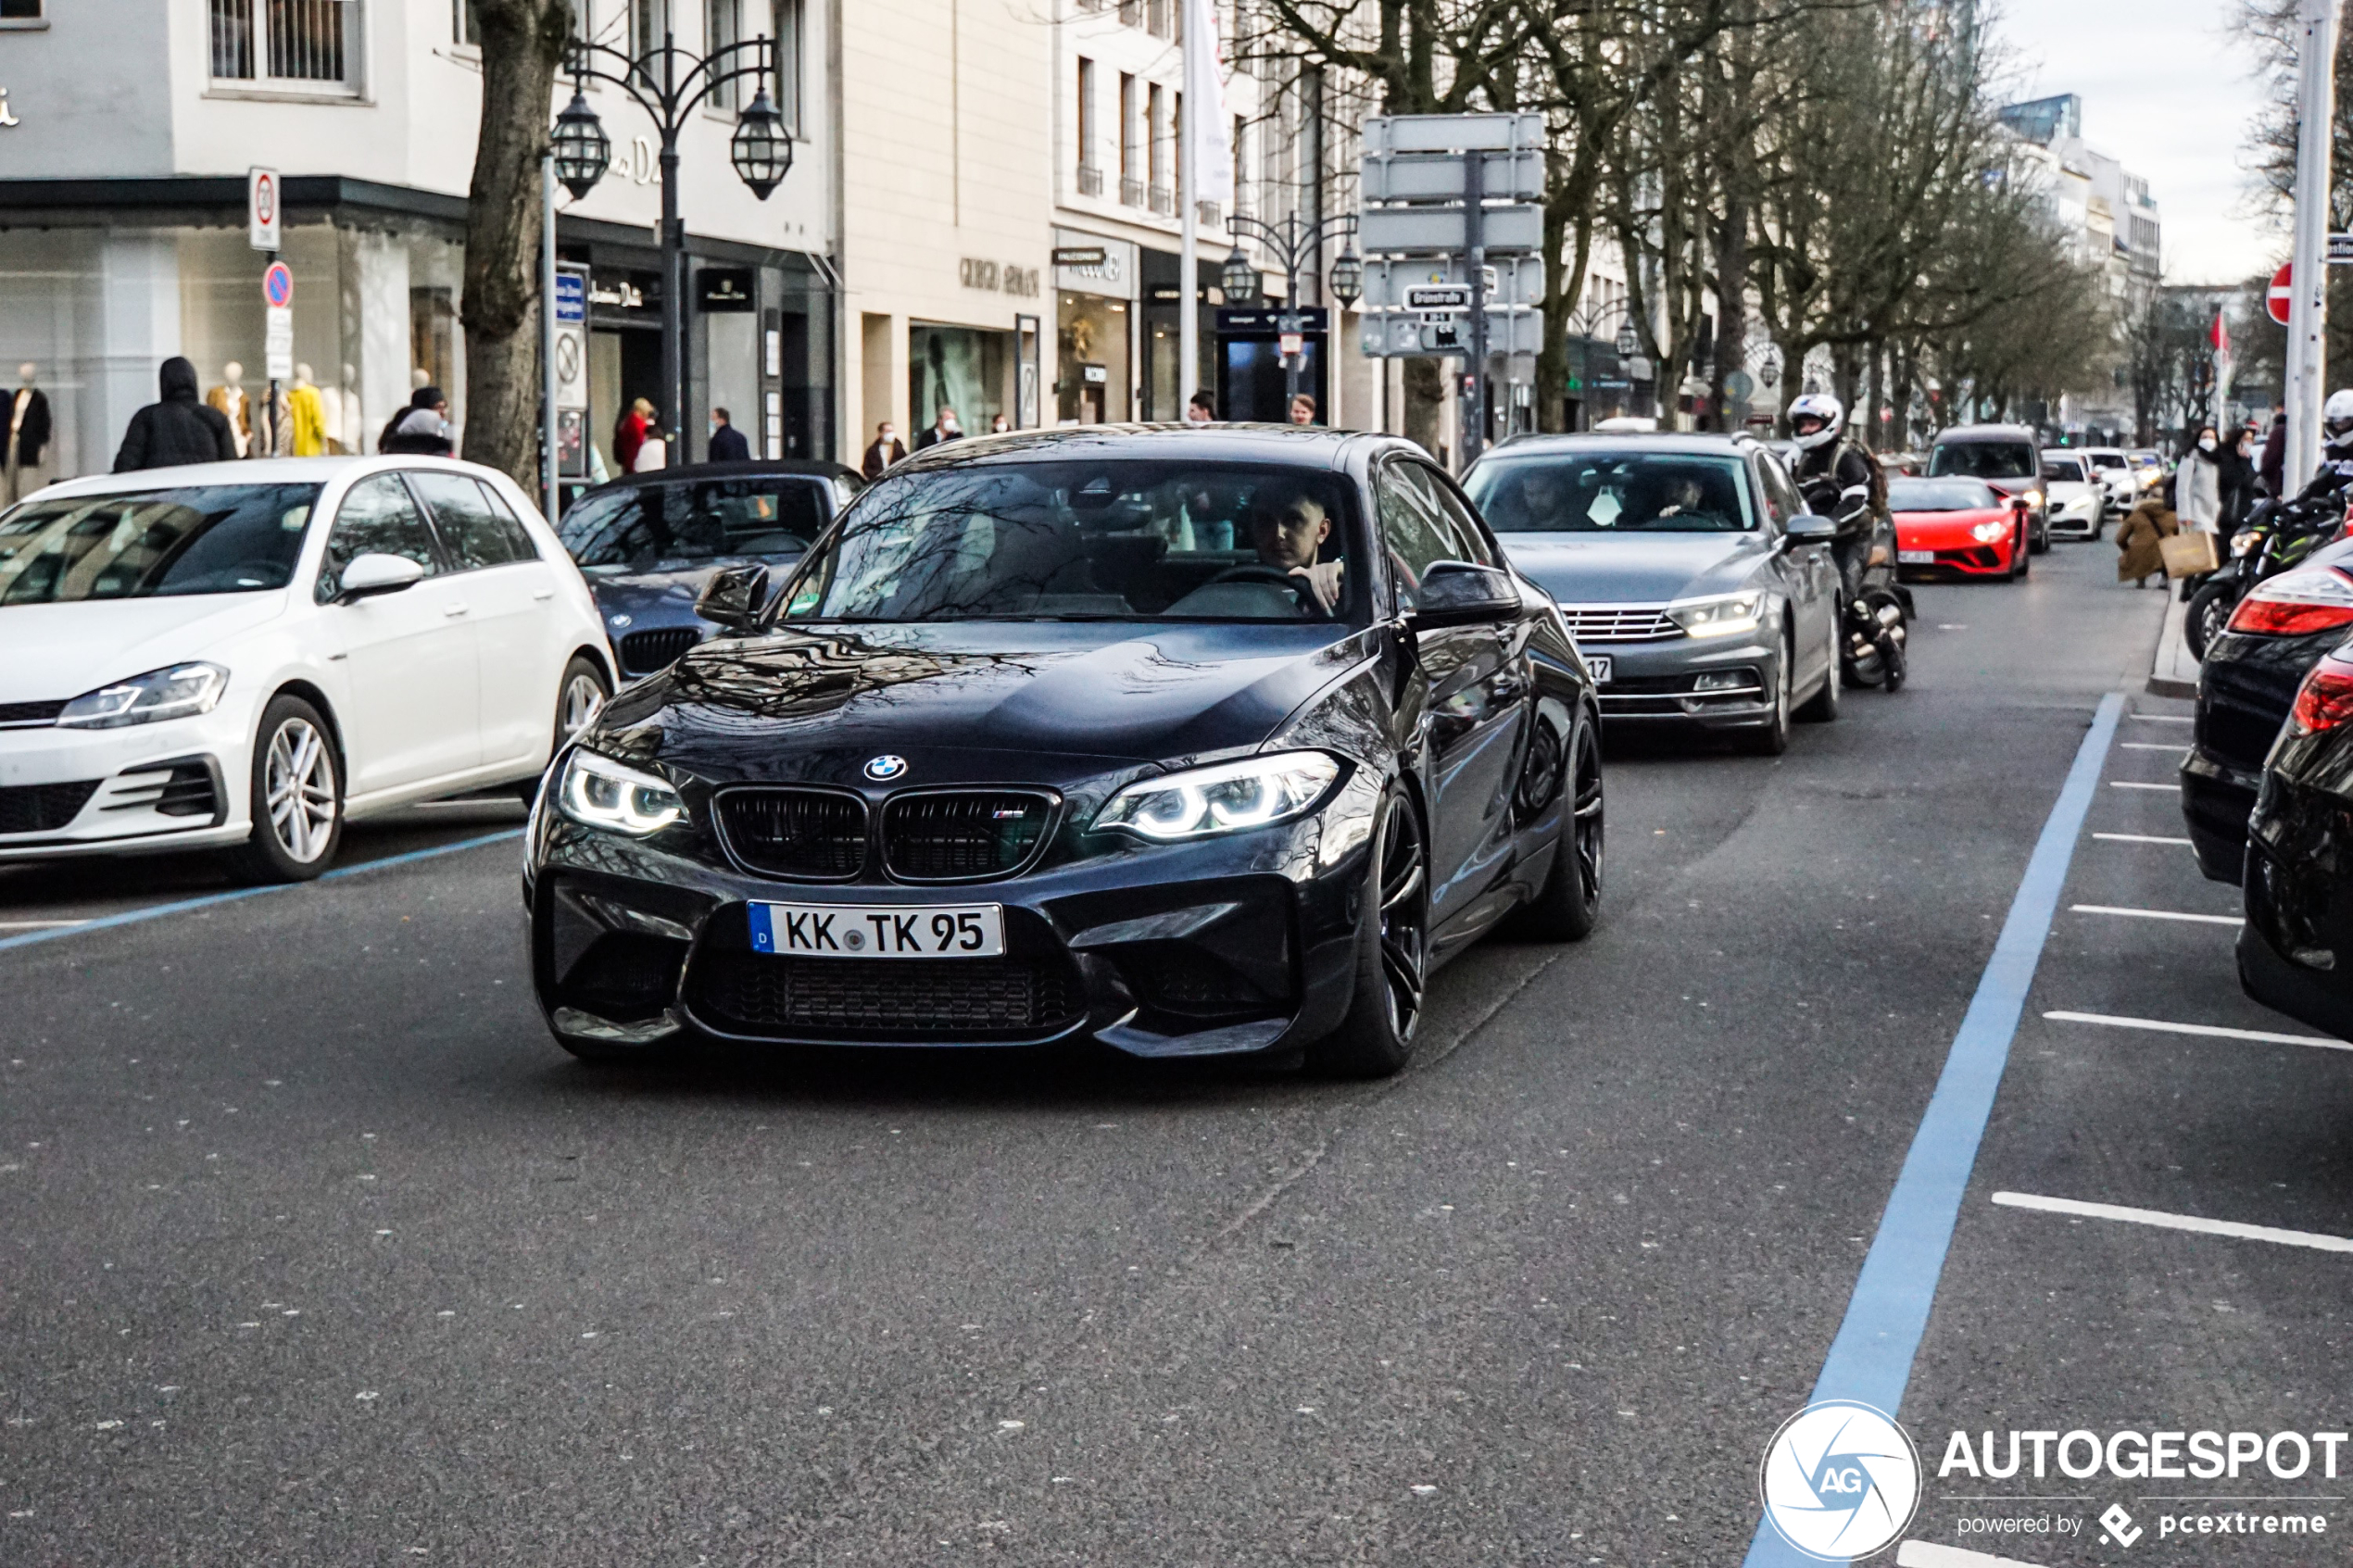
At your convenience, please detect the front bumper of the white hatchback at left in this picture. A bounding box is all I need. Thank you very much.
[0,708,252,860]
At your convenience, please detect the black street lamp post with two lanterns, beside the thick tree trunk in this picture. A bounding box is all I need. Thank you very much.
[546,33,793,456]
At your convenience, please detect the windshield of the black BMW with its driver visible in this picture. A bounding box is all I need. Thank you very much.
[784,458,1360,621]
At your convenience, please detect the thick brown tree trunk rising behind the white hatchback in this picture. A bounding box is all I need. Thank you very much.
[461,0,572,494]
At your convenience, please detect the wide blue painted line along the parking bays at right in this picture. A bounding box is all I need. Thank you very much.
[1743,691,2125,1568]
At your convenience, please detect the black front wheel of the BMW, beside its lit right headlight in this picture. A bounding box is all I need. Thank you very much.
[1308,790,1430,1079]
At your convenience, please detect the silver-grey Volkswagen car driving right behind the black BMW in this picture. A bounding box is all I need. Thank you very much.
[1464,435,1840,752]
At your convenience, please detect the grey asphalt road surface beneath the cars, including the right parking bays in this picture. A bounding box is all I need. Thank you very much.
[0,546,2353,1565]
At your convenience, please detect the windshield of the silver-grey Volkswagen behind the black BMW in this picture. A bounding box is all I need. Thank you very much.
[1466,451,1757,533]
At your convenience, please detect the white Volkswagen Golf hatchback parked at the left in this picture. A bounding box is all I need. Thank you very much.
[0,458,611,882]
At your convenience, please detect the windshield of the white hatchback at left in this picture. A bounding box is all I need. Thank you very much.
[0,484,320,604]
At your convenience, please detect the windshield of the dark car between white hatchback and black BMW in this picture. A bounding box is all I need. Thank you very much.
[558,475,826,571]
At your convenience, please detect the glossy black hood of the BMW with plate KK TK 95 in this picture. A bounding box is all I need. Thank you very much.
[596,623,1369,785]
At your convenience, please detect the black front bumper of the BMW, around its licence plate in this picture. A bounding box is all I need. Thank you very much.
[524,769,1378,1058]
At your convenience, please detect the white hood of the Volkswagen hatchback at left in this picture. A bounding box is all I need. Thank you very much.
[0,590,287,703]
